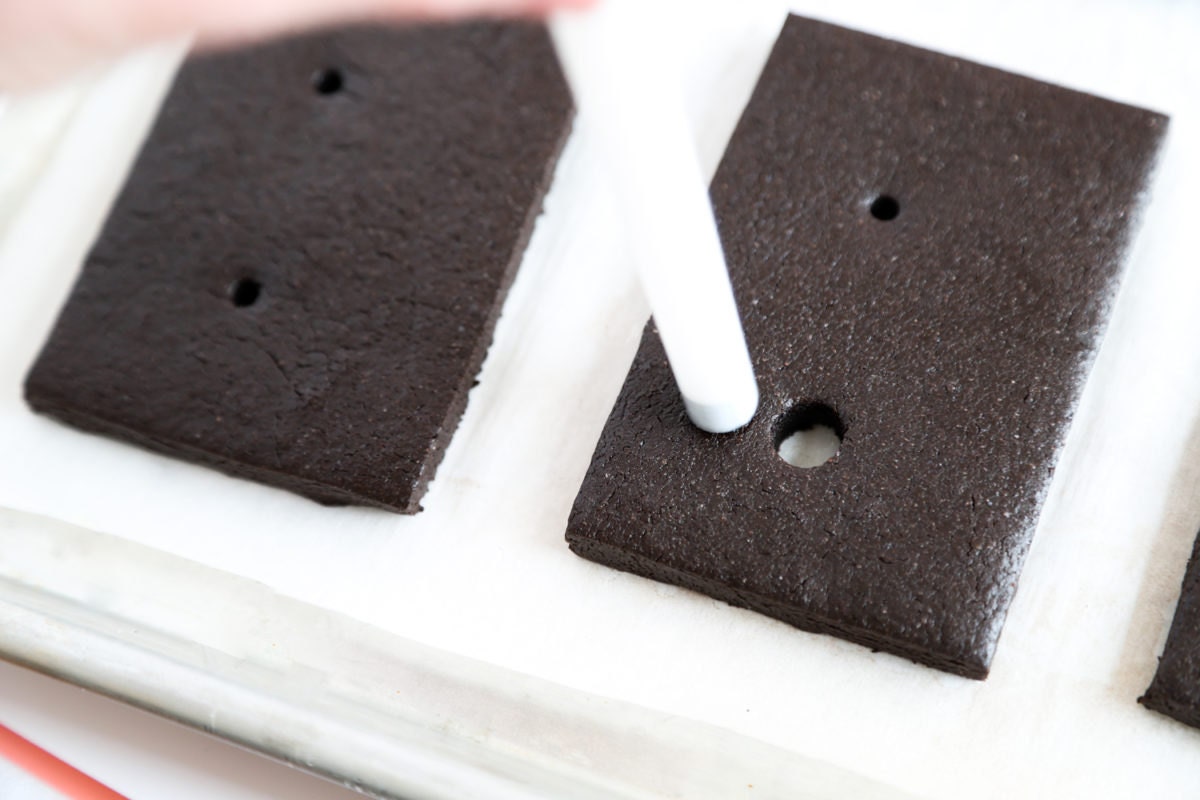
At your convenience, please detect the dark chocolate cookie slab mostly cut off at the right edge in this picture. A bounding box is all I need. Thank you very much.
[1141,537,1200,728]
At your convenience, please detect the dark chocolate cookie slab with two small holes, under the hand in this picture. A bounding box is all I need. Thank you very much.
[26,23,572,512]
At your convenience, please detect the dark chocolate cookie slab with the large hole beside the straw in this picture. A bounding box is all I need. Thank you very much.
[566,17,1166,679]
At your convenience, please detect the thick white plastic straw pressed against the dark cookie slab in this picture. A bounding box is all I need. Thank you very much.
[552,0,758,433]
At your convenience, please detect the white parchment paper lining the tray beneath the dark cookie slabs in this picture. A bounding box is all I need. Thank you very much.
[0,0,1200,798]
